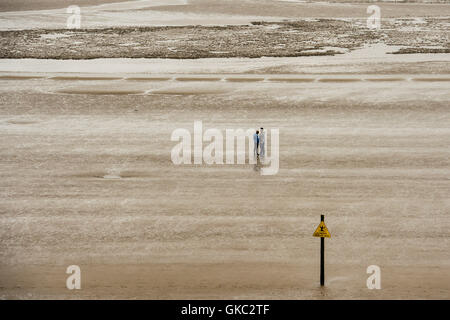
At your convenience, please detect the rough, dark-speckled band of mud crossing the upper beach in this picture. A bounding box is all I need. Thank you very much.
[0,18,450,59]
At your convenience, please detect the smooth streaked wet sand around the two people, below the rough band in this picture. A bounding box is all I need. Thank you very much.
[0,55,450,299]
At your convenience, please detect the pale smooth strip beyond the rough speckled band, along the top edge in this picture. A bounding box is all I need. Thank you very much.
[0,0,448,30]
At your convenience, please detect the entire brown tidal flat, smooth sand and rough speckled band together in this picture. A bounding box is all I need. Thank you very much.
[0,0,450,299]
